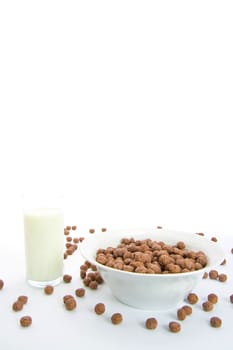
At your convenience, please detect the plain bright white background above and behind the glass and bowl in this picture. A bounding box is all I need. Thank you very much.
[0,0,233,348]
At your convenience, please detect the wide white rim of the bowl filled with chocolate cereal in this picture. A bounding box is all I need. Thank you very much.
[80,228,225,279]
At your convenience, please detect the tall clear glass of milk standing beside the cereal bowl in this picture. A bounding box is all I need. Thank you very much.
[23,194,64,287]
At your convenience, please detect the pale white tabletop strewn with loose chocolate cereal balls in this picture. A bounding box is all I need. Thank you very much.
[0,223,233,350]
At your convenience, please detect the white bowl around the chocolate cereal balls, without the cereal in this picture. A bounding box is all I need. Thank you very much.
[80,229,224,310]
